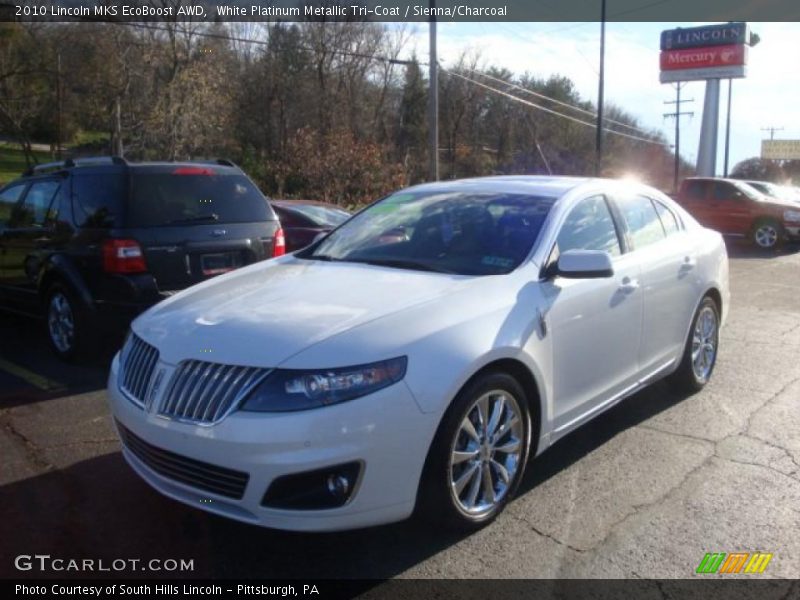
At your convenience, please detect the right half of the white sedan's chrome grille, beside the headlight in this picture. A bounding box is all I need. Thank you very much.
[158,360,269,424]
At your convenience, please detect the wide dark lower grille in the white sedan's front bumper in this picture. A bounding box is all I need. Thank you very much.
[117,421,250,499]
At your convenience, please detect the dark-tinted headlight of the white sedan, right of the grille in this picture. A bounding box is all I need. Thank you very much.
[241,356,408,412]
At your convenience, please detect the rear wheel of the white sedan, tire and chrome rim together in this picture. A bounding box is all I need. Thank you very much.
[670,296,719,394]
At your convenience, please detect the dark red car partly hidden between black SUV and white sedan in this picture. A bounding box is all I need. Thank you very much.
[270,200,350,252]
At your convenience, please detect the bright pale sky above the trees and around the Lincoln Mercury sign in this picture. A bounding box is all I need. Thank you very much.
[396,22,800,175]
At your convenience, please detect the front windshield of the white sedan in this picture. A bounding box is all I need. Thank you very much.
[301,191,556,275]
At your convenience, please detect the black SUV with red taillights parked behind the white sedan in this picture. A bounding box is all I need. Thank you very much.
[0,157,285,358]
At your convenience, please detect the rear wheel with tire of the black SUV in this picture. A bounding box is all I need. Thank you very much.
[45,283,94,361]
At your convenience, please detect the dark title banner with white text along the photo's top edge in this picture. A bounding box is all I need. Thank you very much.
[0,0,800,22]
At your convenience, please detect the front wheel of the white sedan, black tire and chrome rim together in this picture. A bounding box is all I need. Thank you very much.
[417,372,531,530]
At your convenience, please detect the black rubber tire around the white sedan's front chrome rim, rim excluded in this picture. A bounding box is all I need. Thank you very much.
[418,371,532,530]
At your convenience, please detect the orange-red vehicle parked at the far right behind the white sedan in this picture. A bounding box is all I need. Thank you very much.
[677,177,800,249]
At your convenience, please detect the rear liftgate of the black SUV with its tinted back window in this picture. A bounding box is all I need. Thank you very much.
[121,166,278,291]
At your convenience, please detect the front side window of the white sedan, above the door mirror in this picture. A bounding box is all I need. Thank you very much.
[556,196,622,256]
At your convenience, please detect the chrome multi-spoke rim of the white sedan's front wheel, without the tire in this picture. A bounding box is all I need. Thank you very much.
[449,390,524,517]
